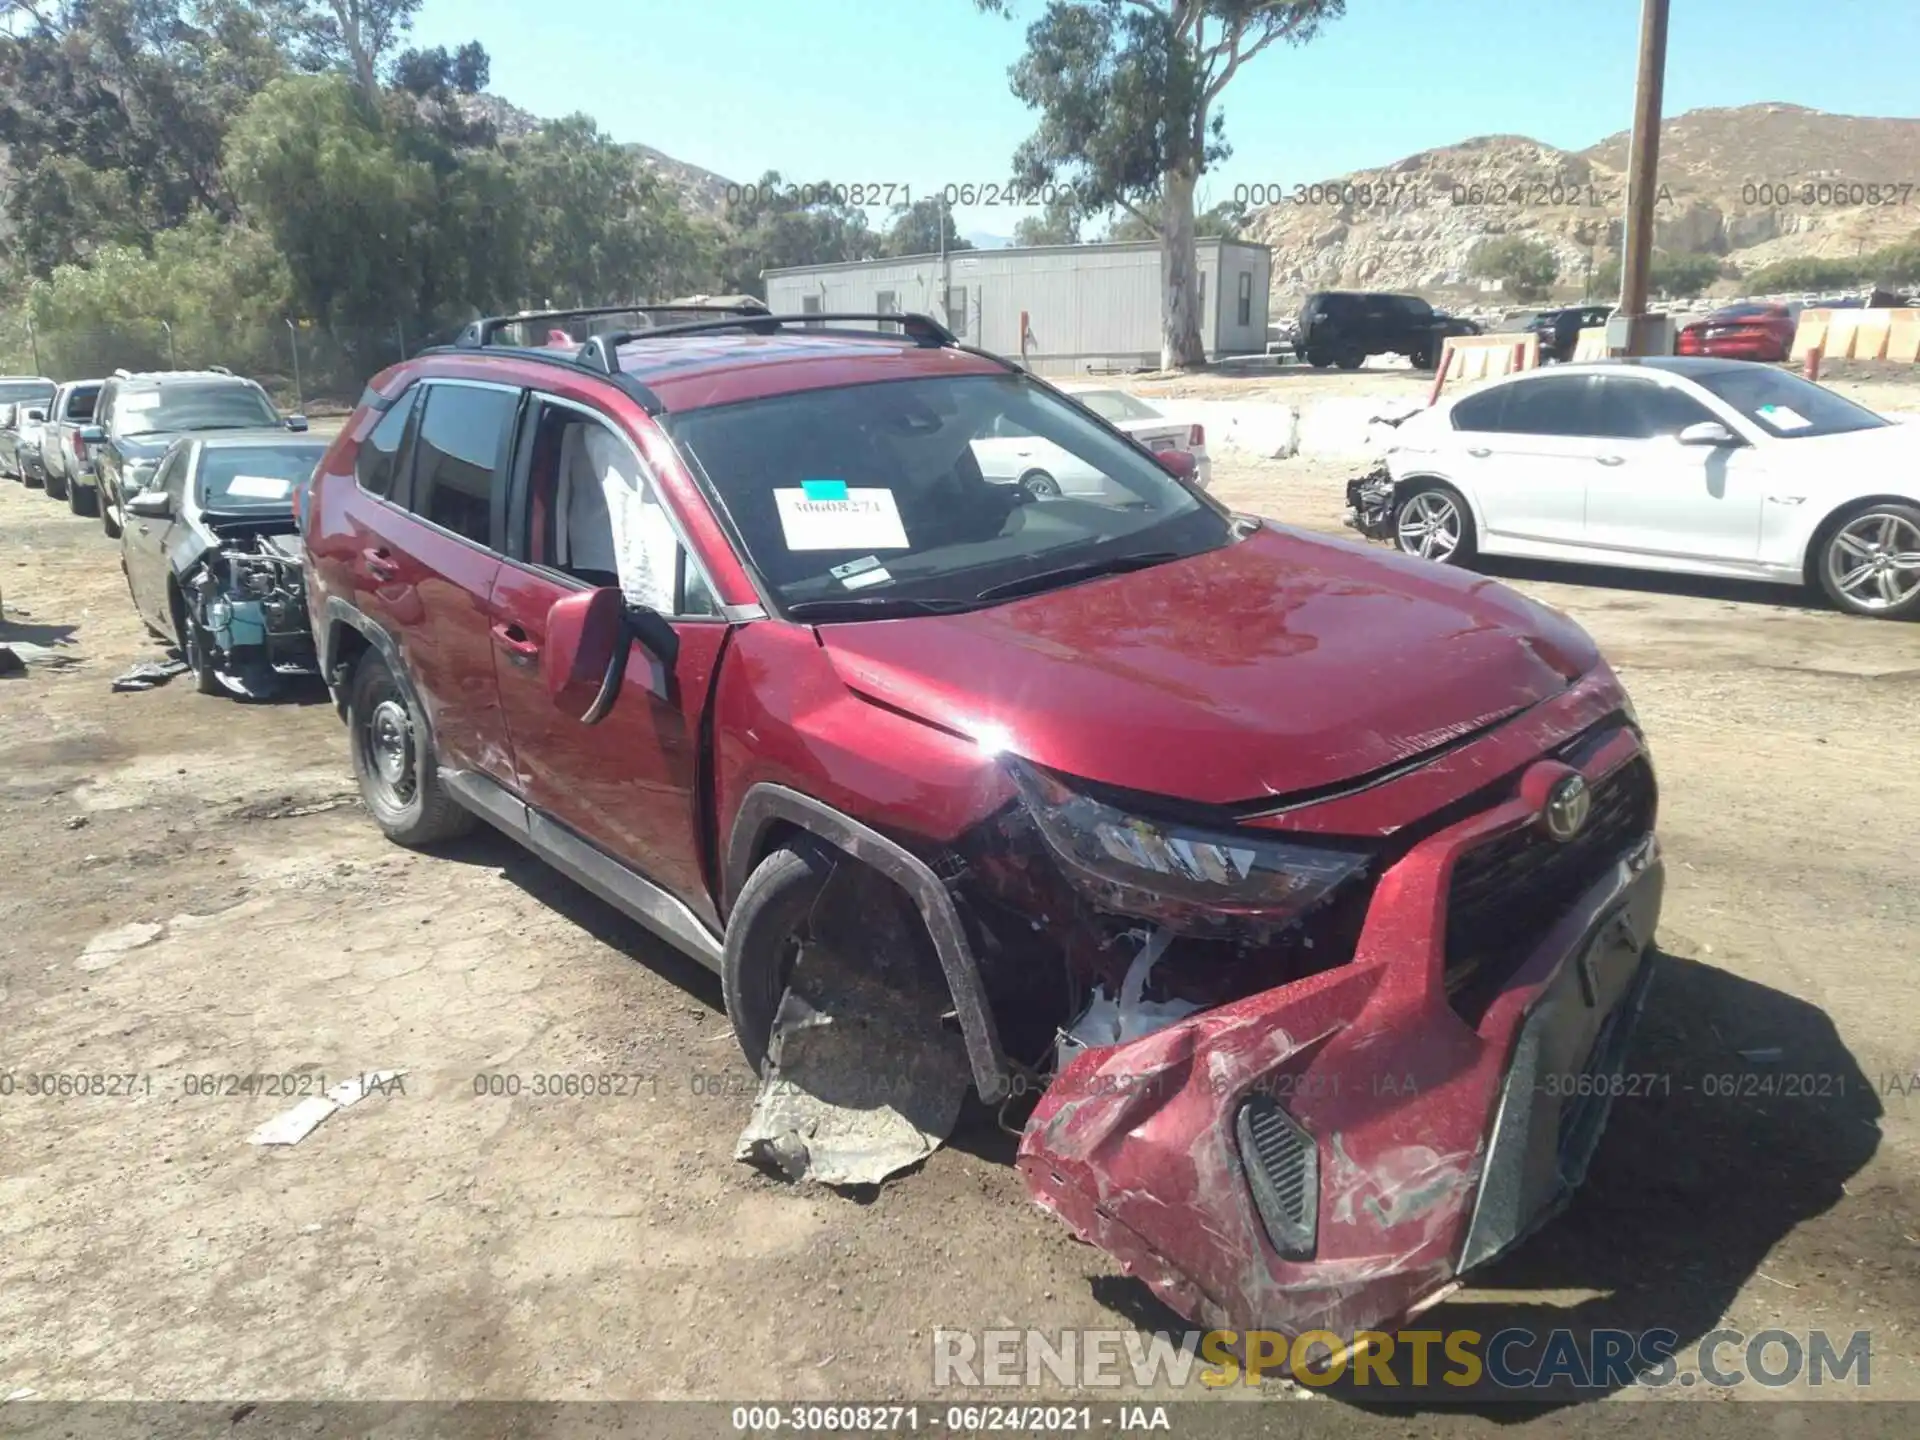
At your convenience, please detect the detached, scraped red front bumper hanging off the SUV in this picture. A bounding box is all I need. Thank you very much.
[1018,726,1663,1342]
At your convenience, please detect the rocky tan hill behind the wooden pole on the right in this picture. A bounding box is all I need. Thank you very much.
[1248,104,1920,301]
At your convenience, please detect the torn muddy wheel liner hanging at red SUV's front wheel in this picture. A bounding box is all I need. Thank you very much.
[733,966,973,1185]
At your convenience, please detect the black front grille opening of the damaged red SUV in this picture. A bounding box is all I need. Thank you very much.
[1446,756,1653,1025]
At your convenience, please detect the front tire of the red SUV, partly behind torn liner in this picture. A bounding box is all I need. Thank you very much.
[720,841,833,1075]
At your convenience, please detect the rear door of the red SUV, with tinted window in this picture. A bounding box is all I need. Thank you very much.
[349,380,522,780]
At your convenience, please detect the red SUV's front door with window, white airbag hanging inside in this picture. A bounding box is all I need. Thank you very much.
[490,397,728,927]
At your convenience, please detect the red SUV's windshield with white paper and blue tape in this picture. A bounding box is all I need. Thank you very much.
[668,374,1229,618]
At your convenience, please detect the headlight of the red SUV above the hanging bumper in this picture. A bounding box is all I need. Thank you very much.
[1006,756,1371,924]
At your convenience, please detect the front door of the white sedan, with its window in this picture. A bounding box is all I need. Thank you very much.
[1586,374,1764,561]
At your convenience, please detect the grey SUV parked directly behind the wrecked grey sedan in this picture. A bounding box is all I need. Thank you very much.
[69,369,307,540]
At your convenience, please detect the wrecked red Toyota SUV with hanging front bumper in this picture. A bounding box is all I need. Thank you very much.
[301,313,1663,1332]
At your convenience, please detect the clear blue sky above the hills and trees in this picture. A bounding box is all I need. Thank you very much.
[415,0,1920,234]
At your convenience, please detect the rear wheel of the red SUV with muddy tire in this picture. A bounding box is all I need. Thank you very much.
[348,651,474,849]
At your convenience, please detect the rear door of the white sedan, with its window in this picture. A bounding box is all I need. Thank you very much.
[1453,372,1594,551]
